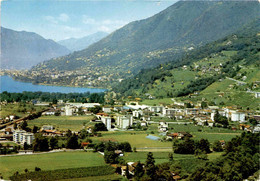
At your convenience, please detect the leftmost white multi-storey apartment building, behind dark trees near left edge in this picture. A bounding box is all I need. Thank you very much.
[13,130,34,145]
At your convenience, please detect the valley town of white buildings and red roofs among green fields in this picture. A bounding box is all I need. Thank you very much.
[0,93,260,180]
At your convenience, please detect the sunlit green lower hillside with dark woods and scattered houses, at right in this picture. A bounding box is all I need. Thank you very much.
[113,19,260,109]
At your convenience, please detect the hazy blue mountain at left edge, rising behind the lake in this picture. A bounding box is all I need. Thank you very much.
[1,27,70,69]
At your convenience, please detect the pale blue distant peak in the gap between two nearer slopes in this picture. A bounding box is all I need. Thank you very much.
[57,32,108,51]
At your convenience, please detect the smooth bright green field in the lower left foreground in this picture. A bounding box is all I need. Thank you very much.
[0,151,105,179]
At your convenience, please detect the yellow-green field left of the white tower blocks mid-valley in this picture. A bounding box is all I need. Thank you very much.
[28,116,93,131]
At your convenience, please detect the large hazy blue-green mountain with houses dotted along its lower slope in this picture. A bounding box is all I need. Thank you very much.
[33,1,260,78]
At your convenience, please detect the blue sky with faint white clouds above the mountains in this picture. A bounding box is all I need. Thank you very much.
[1,0,175,41]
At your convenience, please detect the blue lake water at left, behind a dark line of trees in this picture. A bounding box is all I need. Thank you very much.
[0,76,106,93]
